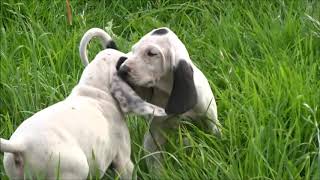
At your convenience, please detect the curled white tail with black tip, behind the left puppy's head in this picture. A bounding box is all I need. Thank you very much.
[79,28,117,66]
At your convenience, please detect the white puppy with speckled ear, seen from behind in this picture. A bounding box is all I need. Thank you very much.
[0,39,166,179]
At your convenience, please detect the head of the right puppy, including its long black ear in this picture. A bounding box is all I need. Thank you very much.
[117,28,197,114]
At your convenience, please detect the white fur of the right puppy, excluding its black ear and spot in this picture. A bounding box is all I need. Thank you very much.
[121,27,220,170]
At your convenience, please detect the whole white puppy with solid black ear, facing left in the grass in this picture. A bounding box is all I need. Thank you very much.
[118,27,220,167]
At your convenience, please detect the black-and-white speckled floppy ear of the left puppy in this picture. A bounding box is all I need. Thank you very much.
[110,74,167,116]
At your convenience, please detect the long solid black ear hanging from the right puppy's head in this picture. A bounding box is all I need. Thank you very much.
[165,60,197,114]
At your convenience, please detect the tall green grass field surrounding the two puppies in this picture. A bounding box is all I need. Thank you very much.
[0,0,320,180]
